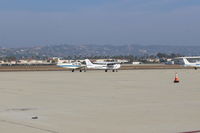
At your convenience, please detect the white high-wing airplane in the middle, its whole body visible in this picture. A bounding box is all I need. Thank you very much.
[85,59,121,72]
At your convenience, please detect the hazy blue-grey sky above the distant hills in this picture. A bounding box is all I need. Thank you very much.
[0,0,200,47]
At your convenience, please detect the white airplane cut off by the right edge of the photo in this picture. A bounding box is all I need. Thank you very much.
[181,57,200,69]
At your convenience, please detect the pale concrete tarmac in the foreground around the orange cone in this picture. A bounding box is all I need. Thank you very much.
[0,69,200,133]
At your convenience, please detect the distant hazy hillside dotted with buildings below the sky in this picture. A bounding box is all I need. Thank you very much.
[0,45,200,58]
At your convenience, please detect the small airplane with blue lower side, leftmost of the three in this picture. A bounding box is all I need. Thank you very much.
[57,62,85,72]
